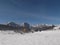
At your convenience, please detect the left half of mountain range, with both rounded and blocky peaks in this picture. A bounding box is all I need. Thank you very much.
[0,22,30,32]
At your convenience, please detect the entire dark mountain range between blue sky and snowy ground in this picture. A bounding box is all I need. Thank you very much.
[0,22,56,32]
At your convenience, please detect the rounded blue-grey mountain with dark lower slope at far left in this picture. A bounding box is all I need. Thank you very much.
[0,22,21,31]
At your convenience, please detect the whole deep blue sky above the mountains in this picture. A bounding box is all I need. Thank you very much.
[0,0,60,24]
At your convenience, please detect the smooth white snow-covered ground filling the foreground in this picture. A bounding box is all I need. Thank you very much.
[0,30,60,45]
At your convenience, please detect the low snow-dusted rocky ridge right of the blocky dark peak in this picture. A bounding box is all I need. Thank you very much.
[31,24,55,31]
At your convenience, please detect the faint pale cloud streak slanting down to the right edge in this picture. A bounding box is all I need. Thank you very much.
[15,12,60,21]
